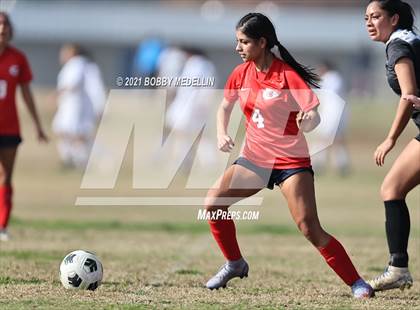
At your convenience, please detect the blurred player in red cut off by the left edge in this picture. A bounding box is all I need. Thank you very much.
[0,12,47,241]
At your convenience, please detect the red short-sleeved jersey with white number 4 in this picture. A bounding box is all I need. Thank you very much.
[224,58,319,169]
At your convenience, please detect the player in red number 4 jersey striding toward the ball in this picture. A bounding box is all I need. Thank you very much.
[205,13,373,298]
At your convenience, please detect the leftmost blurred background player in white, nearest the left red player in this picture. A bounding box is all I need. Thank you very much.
[53,44,105,168]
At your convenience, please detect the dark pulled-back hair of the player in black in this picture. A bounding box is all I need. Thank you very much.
[369,0,415,31]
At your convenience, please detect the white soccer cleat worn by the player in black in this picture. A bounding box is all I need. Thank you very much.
[368,266,413,291]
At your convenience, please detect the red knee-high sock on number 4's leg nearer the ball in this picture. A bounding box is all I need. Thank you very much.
[208,220,242,261]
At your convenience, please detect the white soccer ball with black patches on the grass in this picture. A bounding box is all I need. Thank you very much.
[60,250,103,291]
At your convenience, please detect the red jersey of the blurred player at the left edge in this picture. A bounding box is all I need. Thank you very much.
[0,46,32,135]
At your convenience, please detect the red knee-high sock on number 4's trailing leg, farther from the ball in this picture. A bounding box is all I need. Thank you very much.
[318,237,360,285]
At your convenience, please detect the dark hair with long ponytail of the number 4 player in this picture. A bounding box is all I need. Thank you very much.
[236,13,320,88]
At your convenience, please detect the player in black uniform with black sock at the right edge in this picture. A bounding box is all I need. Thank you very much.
[365,0,420,291]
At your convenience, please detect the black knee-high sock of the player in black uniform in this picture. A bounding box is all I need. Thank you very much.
[384,200,410,267]
